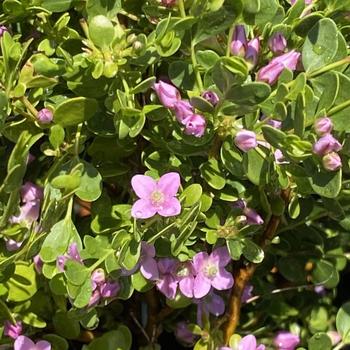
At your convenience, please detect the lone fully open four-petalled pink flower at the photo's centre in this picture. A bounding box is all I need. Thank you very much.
[131,172,181,219]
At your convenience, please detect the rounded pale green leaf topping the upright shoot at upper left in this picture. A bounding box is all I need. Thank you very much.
[89,15,115,49]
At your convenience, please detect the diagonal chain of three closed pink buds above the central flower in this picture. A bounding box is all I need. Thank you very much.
[153,80,207,137]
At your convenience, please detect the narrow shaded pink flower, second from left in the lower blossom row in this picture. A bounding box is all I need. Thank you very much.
[156,258,178,299]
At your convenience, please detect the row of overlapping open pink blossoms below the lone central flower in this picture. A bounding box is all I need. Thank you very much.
[139,242,234,299]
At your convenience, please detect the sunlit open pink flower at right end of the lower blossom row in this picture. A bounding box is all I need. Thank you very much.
[193,247,233,298]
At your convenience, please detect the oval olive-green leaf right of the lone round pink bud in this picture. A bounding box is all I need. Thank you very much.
[54,97,97,127]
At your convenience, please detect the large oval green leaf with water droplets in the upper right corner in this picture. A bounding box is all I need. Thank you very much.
[301,18,338,72]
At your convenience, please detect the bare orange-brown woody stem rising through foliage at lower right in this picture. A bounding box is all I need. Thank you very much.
[223,189,290,344]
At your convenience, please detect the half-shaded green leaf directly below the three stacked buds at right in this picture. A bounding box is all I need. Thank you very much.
[309,170,342,198]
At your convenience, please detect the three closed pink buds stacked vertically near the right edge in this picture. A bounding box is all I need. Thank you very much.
[313,117,342,171]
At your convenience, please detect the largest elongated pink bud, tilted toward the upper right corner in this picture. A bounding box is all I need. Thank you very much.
[257,50,300,85]
